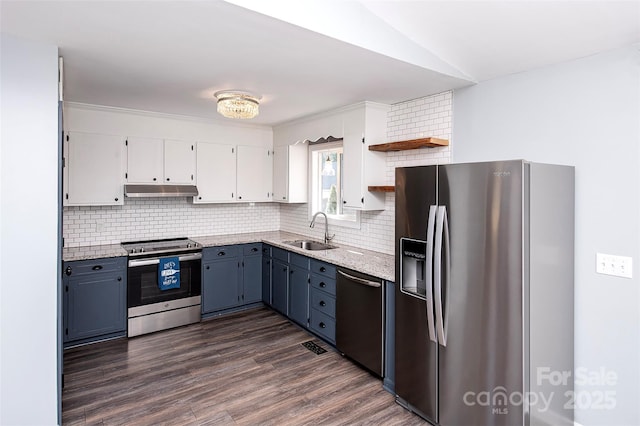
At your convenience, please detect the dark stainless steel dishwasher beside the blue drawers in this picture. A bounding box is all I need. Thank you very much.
[336,268,384,377]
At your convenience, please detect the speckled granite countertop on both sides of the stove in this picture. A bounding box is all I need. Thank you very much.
[62,231,395,281]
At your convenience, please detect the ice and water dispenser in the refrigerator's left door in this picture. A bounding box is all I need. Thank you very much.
[400,238,427,299]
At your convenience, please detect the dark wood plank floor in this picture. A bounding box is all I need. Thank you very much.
[62,308,426,425]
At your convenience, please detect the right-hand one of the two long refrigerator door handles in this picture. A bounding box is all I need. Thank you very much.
[433,206,451,346]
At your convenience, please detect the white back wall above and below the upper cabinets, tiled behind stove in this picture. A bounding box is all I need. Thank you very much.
[63,104,280,247]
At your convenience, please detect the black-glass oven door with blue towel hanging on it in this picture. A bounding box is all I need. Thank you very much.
[127,253,202,308]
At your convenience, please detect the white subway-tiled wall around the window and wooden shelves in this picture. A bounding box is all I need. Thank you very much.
[280,92,452,254]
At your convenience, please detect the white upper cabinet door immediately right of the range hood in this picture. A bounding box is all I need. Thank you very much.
[193,142,236,203]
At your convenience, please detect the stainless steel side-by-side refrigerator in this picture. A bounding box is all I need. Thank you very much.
[395,160,574,426]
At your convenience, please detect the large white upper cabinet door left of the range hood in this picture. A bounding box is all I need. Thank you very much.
[64,132,125,206]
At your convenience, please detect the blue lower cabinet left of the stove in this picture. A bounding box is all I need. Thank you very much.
[62,257,127,347]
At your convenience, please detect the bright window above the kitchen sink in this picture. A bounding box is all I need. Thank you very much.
[309,141,360,227]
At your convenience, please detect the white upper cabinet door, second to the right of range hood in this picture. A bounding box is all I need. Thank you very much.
[237,145,273,201]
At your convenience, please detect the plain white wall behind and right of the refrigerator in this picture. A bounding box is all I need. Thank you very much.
[452,46,640,425]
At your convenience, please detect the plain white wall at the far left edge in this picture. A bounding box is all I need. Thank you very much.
[0,34,59,425]
